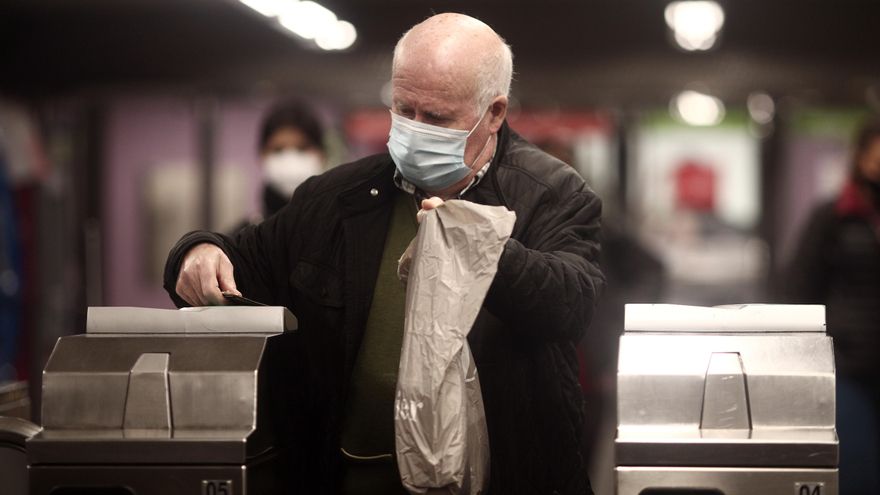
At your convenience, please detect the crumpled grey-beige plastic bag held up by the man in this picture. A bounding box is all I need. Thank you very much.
[394,200,516,495]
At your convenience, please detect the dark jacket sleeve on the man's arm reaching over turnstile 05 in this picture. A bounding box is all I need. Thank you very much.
[164,181,309,307]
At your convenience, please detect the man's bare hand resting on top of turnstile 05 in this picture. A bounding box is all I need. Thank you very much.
[174,243,241,306]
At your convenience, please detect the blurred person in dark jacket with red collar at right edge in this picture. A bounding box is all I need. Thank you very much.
[783,118,880,495]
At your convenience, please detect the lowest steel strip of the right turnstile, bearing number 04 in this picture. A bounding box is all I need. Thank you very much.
[616,466,838,495]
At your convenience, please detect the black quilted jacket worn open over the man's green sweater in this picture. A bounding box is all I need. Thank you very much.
[165,124,604,495]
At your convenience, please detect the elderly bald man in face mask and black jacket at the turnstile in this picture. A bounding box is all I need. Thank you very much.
[165,14,604,495]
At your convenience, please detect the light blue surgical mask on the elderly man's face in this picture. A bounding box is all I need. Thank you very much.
[388,112,491,191]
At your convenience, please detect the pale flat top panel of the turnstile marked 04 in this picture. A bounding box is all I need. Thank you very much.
[624,304,825,333]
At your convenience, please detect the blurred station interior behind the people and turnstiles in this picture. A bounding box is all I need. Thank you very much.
[0,0,880,492]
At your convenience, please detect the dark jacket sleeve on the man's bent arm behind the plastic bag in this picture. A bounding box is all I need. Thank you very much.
[486,186,605,341]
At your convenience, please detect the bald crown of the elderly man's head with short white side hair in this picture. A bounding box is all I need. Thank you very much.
[392,13,513,112]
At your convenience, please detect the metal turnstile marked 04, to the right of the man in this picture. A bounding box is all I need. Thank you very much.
[615,304,838,495]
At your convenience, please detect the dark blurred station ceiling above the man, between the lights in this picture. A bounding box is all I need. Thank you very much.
[0,0,880,107]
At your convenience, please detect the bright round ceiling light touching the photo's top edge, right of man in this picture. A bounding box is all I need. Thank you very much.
[665,0,724,51]
